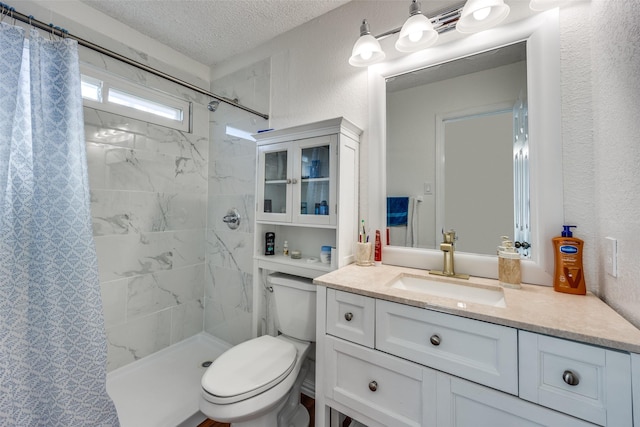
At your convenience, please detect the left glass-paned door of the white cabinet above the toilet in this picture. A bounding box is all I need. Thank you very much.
[257,144,291,221]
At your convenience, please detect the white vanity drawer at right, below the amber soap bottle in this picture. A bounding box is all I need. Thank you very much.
[519,331,632,427]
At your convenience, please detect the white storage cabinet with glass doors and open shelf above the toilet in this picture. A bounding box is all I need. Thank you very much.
[254,117,362,334]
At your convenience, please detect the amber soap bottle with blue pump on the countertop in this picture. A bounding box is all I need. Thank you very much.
[551,225,587,295]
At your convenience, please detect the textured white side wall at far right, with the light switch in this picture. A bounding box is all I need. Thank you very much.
[591,0,640,327]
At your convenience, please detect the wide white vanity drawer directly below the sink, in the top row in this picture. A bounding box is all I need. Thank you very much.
[376,300,518,395]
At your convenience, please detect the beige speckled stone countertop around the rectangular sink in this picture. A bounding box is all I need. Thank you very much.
[314,264,640,353]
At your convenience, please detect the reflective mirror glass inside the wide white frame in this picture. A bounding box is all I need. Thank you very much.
[386,42,533,258]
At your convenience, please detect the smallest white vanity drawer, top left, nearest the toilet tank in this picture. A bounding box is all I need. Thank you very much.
[327,289,375,348]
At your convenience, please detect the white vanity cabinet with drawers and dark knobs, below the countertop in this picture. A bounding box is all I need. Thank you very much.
[316,286,639,427]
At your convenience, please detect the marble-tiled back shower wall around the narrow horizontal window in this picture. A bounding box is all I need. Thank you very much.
[81,50,209,370]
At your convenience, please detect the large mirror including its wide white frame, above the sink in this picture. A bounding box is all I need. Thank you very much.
[368,10,563,285]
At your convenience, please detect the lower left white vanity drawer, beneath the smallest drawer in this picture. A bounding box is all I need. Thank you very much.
[325,336,436,427]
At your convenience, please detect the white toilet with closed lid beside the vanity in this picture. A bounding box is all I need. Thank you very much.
[200,273,316,427]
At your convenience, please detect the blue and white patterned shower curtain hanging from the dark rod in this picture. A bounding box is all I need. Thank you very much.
[0,23,119,427]
